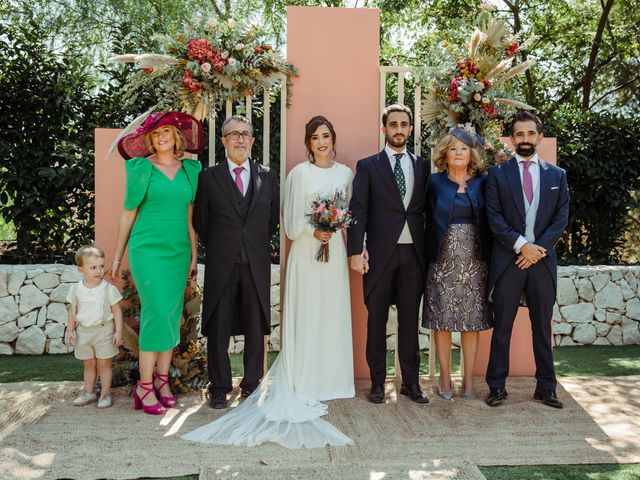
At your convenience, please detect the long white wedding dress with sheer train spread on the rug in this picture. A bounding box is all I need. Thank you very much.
[182,162,355,448]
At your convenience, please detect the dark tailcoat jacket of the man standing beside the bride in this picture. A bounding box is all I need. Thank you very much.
[347,150,429,299]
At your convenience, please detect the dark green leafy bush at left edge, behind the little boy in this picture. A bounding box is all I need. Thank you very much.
[0,14,93,260]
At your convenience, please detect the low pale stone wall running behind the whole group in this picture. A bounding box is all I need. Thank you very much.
[0,265,640,355]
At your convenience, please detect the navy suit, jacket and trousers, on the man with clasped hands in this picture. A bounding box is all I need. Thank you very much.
[485,157,569,390]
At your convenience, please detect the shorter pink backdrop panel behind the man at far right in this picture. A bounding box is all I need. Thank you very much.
[474,137,557,376]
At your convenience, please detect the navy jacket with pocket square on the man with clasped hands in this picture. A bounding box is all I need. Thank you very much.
[485,157,569,292]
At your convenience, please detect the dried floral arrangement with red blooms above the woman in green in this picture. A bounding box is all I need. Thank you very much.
[110,18,297,120]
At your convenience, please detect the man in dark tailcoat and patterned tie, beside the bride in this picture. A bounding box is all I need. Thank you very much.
[348,105,429,403]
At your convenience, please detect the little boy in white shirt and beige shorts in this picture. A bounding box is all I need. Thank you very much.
[65,245,123,408]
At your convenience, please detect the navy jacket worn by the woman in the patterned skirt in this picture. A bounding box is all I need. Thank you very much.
[425,172,491,263]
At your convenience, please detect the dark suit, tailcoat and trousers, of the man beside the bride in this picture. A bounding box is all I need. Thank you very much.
[347,150,428,385]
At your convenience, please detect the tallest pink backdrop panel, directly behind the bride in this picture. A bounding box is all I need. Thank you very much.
[283,7,380,378]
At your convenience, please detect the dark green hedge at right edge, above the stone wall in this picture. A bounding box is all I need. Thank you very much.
[545,107,640,264]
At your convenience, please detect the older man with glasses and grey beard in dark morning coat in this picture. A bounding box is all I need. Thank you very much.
[193,115,280,408]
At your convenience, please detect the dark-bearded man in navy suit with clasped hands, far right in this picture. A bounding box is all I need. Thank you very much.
[486,111,569,408]
